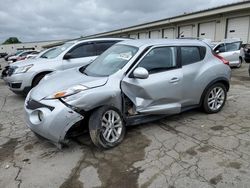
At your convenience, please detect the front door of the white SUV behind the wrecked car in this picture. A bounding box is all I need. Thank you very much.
[63,42,97,69]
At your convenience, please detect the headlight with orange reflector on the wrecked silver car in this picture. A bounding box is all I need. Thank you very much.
[45,85,88,99]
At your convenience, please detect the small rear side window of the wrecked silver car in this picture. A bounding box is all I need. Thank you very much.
[181,46,206,66]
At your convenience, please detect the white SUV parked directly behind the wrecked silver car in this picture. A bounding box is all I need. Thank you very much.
[4,38,128,95]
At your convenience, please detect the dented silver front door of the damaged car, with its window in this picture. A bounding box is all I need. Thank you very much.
[121,46,183,114]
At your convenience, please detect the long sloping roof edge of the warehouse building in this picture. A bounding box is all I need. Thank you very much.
[83,1,250,38]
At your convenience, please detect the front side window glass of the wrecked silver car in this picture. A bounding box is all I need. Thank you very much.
[138,47,177,73]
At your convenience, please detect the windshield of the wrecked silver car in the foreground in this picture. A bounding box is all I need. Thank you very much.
[81,44,138,77]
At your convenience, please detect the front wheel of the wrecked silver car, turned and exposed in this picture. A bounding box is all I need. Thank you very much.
[89,106,126,149]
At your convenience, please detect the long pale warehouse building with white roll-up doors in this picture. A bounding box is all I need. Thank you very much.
[86,1,250,43]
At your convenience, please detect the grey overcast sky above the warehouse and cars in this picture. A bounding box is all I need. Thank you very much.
[0,0,242,43]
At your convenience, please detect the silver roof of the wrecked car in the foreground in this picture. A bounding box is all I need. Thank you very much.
[119,39,206,48]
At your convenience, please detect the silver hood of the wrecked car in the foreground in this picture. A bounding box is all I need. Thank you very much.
[30,68,108,101]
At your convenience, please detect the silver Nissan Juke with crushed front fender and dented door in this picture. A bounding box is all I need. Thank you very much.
[24,39,231,148]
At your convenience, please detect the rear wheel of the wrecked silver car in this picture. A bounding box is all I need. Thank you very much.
[202,83,227,114]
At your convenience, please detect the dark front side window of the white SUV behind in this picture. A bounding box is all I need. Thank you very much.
[70,43,95,59]
